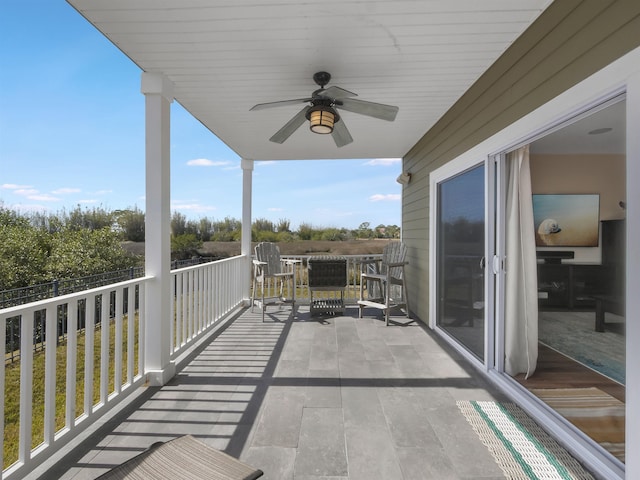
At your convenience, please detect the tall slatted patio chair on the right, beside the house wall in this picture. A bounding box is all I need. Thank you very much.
[358,242,411,325]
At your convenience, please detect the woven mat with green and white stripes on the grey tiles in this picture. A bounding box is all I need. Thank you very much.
[457,401,593,480]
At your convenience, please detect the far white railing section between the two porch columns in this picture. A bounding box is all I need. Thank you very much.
[171,256,249,358]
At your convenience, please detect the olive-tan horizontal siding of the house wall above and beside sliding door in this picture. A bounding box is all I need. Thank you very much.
[402,0,640,323]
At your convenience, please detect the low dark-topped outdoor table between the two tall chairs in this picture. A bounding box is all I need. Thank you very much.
[307,256,347,315]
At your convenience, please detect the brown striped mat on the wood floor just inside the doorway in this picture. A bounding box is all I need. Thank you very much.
[531,387,625,462]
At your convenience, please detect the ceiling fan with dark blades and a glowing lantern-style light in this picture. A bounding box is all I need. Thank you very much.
[250,72,398,147]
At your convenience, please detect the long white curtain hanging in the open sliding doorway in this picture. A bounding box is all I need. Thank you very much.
[505,145,538,378]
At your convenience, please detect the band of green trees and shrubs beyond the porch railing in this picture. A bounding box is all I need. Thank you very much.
[0,203,400,291]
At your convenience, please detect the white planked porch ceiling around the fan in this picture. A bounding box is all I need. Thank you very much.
[67,0,551,160]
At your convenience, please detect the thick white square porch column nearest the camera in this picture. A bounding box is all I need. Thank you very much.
[141,72,175,386]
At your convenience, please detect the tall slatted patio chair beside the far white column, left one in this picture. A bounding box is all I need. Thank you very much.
[251,242,300,322]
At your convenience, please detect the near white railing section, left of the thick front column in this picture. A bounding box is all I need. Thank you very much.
[0,278,148,479]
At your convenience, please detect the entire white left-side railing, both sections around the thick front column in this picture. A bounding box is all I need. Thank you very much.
[0,256,249,480]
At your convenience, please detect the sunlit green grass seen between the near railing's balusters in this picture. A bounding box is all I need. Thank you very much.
[3,314,139,468]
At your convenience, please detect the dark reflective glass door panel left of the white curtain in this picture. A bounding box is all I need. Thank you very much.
[435,164,486,360]
